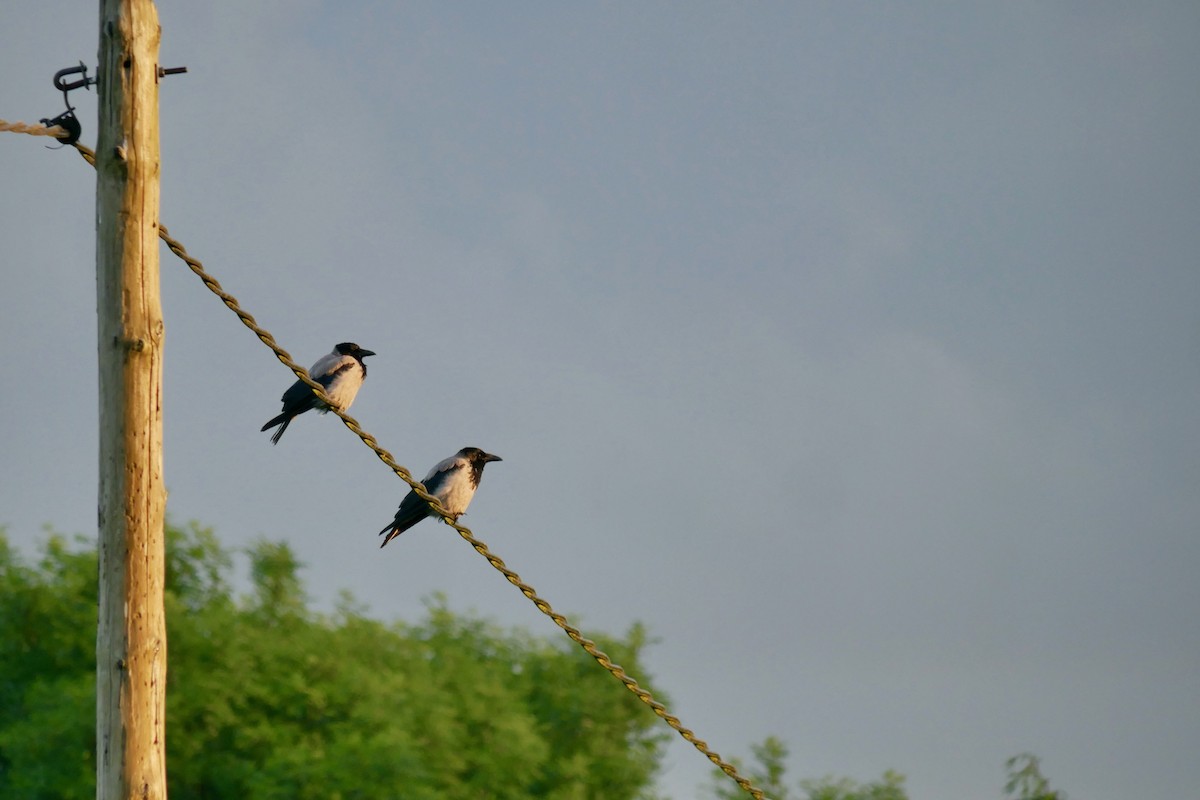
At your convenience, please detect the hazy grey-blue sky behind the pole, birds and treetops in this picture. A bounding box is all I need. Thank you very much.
[0,0,1200,800]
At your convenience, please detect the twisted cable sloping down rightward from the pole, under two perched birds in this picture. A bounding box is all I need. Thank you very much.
[74,143,766,800]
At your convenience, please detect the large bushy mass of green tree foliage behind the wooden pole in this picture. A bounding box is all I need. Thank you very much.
[0,525,667,800]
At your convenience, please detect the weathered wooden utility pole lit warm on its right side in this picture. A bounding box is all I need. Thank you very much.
[96,0,167,800]
